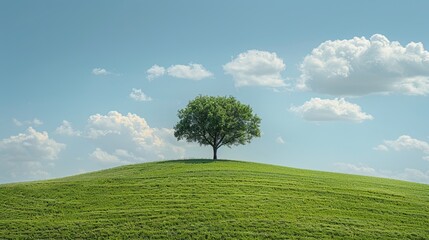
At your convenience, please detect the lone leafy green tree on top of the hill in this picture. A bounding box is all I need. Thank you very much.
[174,95,261,159]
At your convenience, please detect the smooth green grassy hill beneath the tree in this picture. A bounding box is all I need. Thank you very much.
[0,160,429,239]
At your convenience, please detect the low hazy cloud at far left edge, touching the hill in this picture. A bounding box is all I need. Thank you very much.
[0,127,65,180]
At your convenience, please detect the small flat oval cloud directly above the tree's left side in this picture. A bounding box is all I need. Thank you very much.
[167,63,213,80]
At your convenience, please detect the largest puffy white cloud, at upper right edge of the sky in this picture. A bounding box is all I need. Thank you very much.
[297,34,429,96]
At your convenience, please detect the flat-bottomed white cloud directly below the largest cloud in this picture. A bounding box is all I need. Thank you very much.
[290,98,373,122]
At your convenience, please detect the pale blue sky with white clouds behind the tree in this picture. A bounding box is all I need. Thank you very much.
[0,0,429,184]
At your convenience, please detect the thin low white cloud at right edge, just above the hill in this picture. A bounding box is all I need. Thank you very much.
[374,135,429,160]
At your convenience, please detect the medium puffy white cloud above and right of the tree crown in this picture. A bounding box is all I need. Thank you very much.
[223,50,286,88]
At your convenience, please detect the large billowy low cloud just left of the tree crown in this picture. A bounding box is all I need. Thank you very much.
[86,111,185,163]
